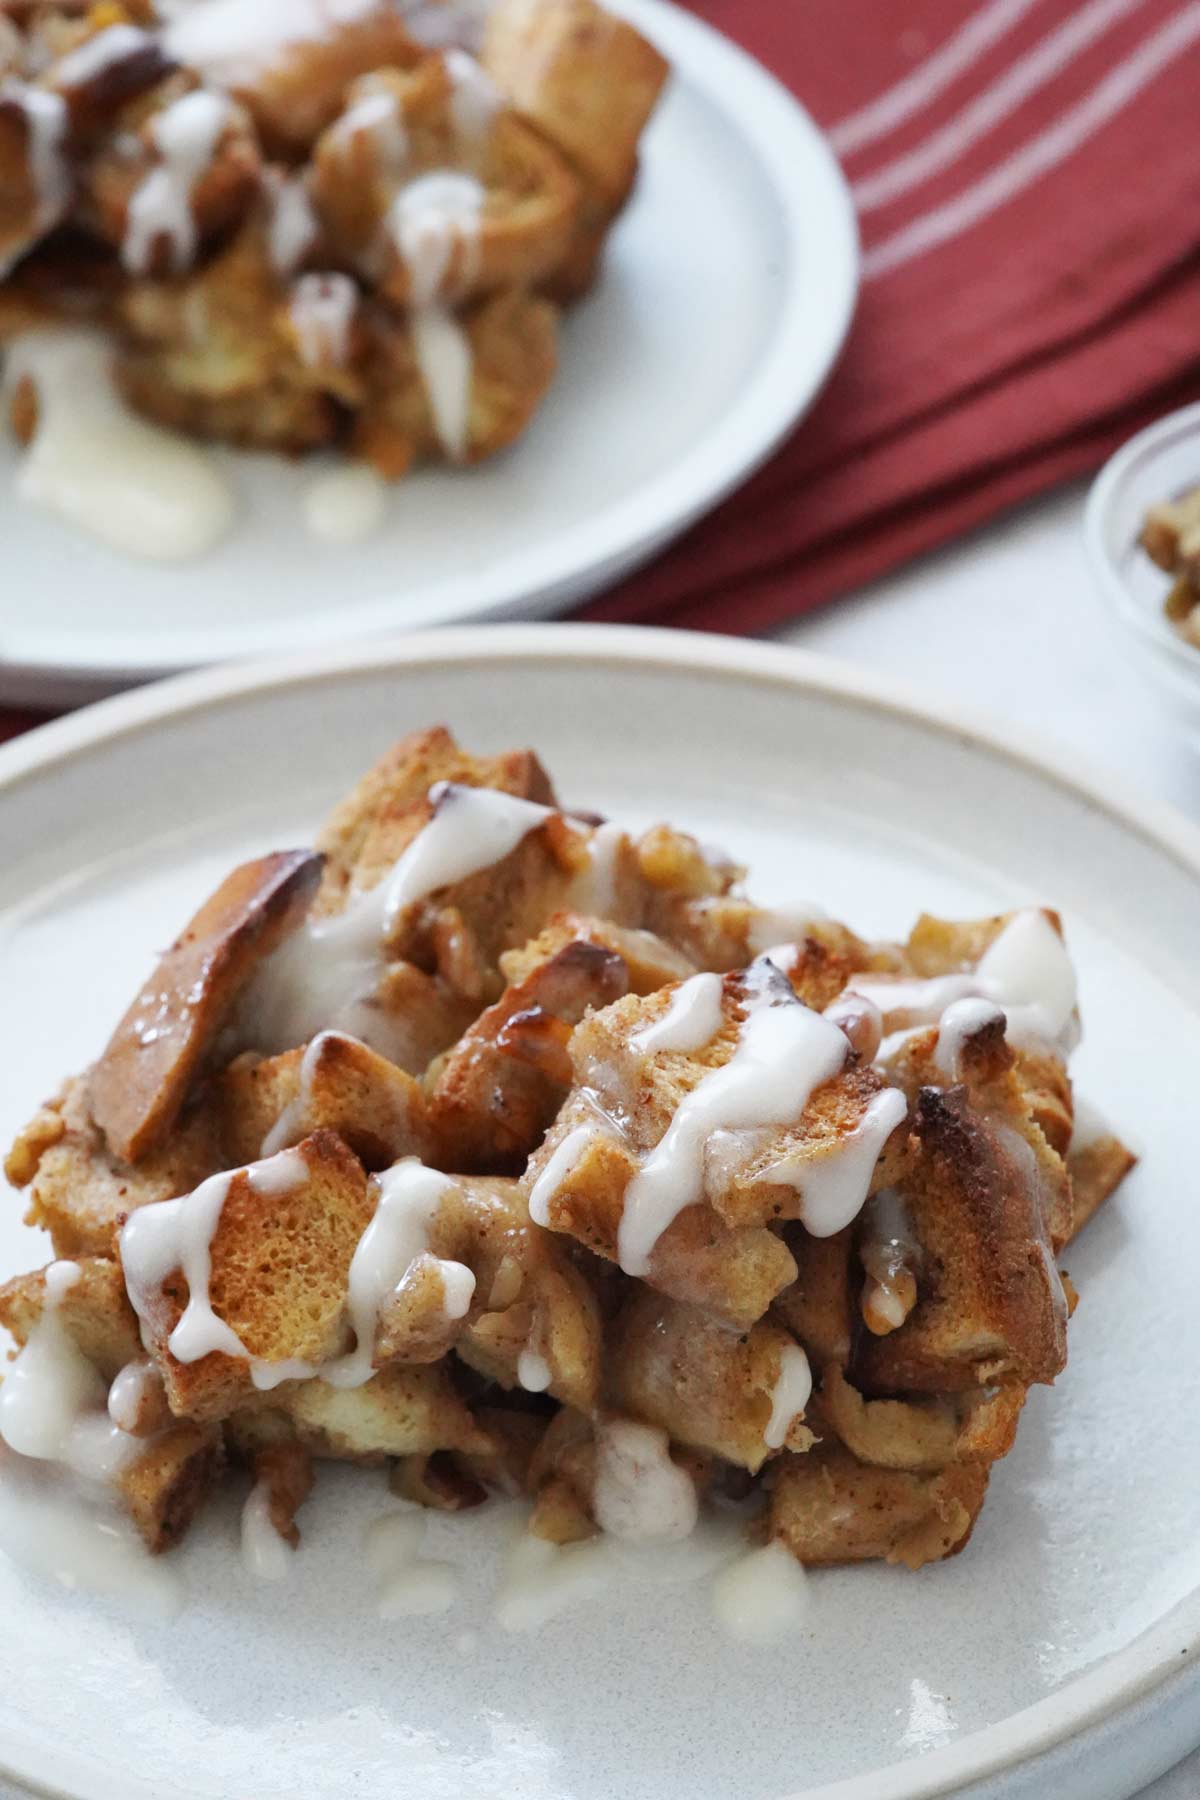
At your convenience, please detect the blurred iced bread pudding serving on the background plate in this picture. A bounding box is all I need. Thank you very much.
[0,0,667,525]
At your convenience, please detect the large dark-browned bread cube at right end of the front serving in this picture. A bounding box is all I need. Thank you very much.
[851,1087,1067,1393]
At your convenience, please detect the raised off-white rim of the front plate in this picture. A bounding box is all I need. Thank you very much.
[0,623,1200,1800]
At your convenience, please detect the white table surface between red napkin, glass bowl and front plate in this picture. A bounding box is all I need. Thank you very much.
[774,486,1200,1800]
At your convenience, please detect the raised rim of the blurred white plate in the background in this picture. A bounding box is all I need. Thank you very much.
[0,0,860,700]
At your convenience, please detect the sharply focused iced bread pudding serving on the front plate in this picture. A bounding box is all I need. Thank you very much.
[0,729,1132,1605]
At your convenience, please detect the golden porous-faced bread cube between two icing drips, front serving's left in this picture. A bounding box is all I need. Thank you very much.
[125,1130,374,1418]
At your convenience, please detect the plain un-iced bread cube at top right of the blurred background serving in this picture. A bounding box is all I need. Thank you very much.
[482,0,667,207]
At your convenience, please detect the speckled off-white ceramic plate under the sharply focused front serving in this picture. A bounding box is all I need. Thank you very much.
[0,626,1200,1800]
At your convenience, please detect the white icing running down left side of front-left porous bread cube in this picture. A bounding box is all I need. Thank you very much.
[119,1150,308,1388]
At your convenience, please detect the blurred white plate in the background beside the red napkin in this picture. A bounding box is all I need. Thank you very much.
[0,0,858,702]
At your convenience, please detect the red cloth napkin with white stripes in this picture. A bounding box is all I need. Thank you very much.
[585,0,1200,632]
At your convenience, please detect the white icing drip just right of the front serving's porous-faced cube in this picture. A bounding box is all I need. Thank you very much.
[320,1156,475,1388]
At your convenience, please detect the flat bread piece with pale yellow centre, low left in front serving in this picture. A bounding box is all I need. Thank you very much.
[227,1364,491,1463]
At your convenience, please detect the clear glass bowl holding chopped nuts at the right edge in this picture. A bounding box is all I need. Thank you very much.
[1083,405,1200,749]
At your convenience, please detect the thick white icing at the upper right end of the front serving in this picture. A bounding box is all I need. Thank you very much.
[849,907,1078,1057]
